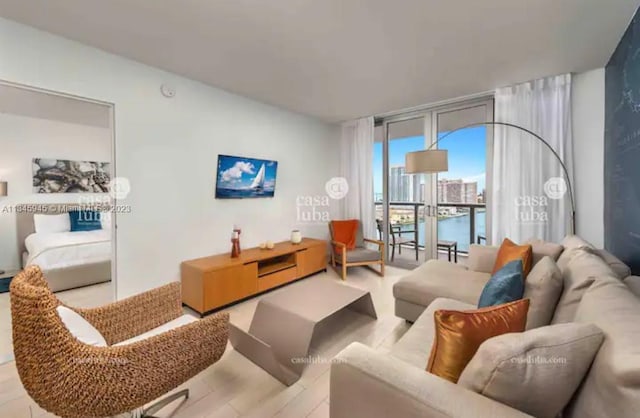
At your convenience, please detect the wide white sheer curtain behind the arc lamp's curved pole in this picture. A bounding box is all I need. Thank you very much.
[490,74,573,245]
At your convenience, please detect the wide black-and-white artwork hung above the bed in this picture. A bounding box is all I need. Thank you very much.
[32,158,111,193]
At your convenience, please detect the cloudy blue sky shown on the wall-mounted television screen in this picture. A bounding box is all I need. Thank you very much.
[218,155,278,190]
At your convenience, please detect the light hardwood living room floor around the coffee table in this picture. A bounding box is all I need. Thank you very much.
[0,267,408,418]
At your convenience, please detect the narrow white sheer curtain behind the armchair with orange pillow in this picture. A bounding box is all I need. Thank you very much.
[340,117,376,238]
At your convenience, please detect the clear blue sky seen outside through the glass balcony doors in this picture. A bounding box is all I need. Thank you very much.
[373,126,486,195]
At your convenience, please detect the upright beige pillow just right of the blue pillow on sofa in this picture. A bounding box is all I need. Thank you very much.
[522,257,564,329]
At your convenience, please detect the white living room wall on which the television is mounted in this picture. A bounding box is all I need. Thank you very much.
[0,19,339,298]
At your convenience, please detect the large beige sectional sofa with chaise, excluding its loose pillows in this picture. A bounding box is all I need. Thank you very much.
[330,237,640,418]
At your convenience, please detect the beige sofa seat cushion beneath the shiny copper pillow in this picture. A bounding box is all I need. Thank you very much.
[391,298,475,370]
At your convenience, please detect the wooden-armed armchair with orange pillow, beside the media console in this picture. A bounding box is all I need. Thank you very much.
[329,219,384,280]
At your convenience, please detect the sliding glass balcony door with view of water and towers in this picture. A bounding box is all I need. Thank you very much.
[374,100,493,268]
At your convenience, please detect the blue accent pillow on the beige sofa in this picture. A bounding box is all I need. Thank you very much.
[478,259,524,308]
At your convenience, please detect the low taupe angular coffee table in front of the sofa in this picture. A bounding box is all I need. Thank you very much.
[229,278,377,386]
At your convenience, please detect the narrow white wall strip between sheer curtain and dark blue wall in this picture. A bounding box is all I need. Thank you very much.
[573,68,605,248]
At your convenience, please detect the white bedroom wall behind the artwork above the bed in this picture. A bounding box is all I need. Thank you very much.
[0,113,111,270]
